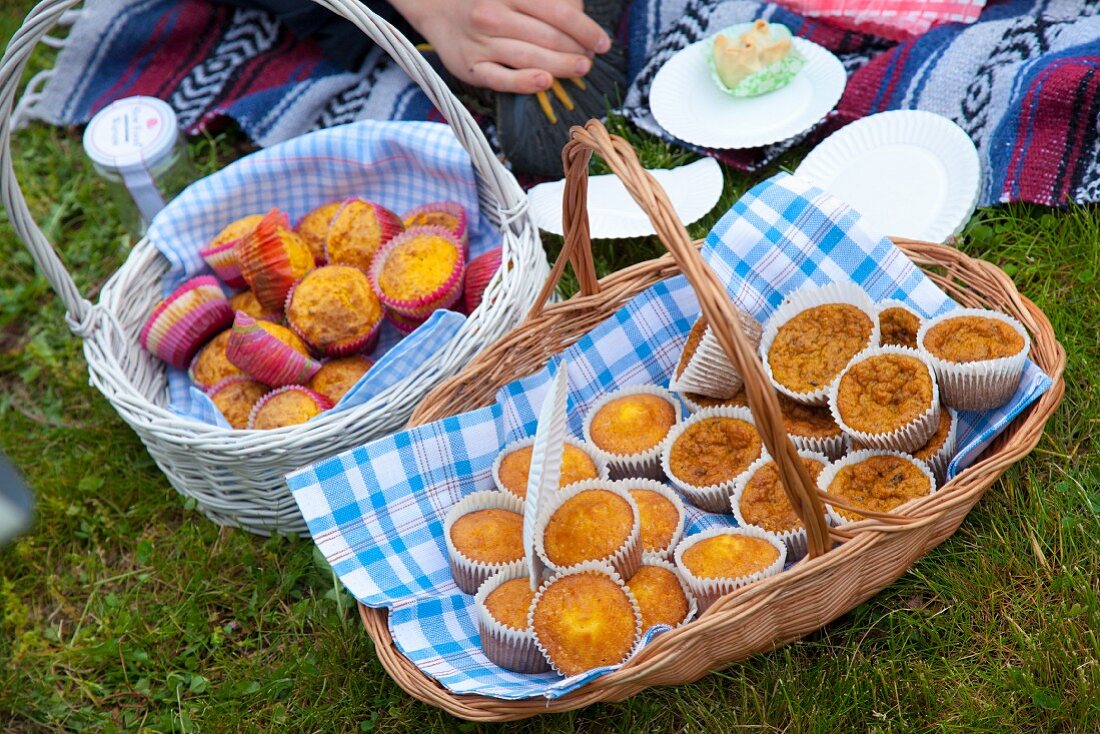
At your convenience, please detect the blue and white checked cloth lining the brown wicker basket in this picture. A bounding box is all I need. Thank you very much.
[287,174,1051,699]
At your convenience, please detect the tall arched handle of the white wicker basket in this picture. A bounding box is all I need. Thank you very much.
[0,0,527,336]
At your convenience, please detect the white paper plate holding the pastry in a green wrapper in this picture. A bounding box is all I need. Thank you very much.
[649,37,848,149]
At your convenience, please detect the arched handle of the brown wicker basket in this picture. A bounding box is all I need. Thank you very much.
[556,120,831,557]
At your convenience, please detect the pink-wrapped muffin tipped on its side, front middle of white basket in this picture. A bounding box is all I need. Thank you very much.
[226,311,321,387]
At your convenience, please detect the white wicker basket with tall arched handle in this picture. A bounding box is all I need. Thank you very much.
[0,0,549,535]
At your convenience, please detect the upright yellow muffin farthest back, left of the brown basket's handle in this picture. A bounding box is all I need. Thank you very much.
[584,385,680,479]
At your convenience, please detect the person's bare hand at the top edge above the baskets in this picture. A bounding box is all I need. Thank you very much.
[392,0,612,94]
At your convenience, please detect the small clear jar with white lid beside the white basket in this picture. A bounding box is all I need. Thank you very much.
[84,97,197,237]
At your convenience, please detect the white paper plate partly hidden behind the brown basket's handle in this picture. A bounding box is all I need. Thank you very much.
[527,158,722,240]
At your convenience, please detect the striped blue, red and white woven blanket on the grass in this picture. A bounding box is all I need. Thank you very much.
[20,0,1100,205]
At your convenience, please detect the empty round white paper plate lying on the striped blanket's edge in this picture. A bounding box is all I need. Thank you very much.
[794,110,981,242]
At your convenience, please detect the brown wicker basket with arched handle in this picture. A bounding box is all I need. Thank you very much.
[360,121,1066,721]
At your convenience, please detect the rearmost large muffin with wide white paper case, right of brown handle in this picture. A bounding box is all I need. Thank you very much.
[760,283,879,405]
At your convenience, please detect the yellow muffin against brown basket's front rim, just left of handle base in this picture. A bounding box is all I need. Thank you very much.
[674,527,787,612]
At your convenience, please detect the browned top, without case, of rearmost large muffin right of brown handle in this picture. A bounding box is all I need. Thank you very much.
[767,304,875,394]
